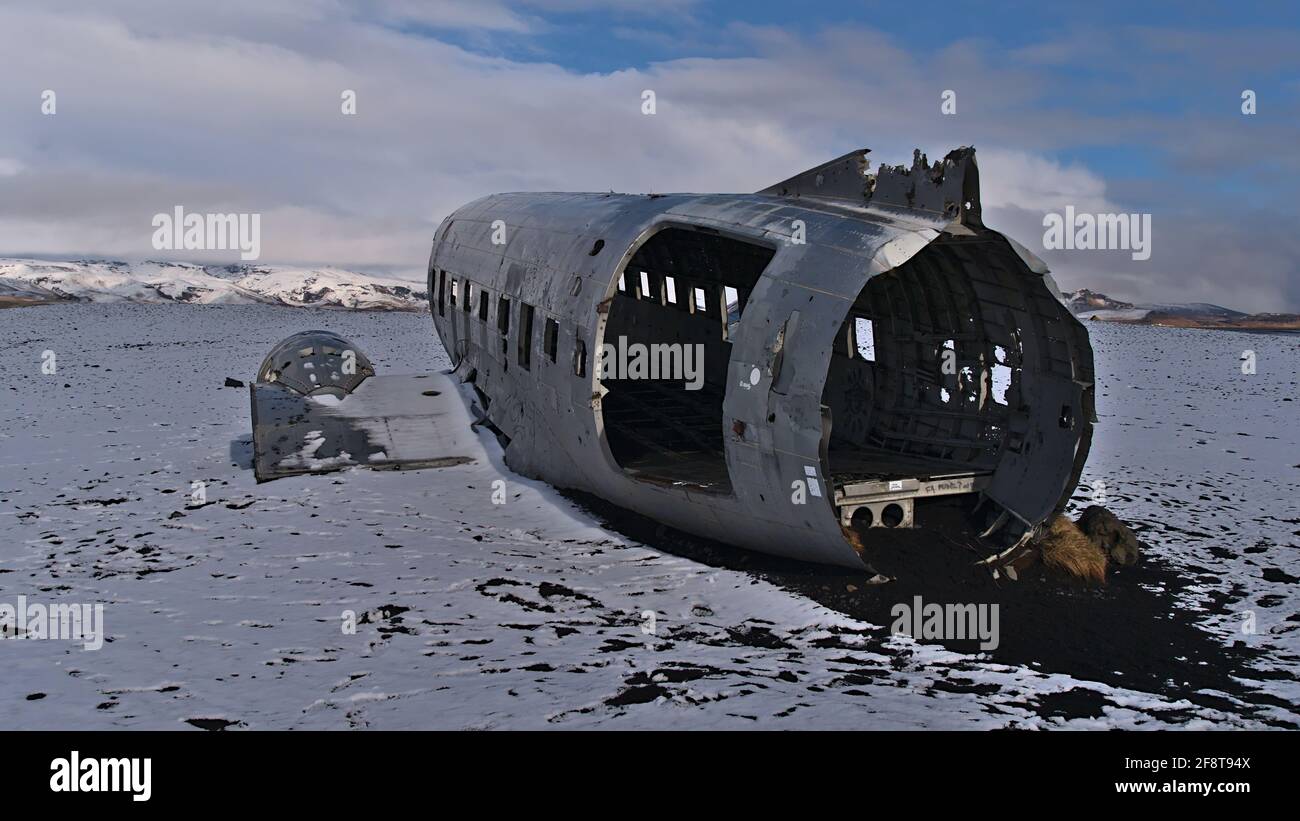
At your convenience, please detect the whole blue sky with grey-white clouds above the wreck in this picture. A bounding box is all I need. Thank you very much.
[0,0,1300,312]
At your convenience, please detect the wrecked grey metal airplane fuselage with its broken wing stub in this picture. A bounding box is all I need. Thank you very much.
[252,148,1095,568]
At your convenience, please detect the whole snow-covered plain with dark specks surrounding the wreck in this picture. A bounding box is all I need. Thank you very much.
[0,304,1300,729]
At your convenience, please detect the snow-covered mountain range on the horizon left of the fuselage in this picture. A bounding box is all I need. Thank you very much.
[0,259,429,310]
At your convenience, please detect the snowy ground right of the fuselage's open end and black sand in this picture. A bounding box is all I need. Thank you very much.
[1075,322,1300,711]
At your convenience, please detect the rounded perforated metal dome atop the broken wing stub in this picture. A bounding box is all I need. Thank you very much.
[257,330,374,399]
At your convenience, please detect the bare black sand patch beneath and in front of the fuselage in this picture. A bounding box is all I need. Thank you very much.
[566,491,1297,729]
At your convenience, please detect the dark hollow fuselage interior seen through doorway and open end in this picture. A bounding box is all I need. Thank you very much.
[598,227,1086,545]
